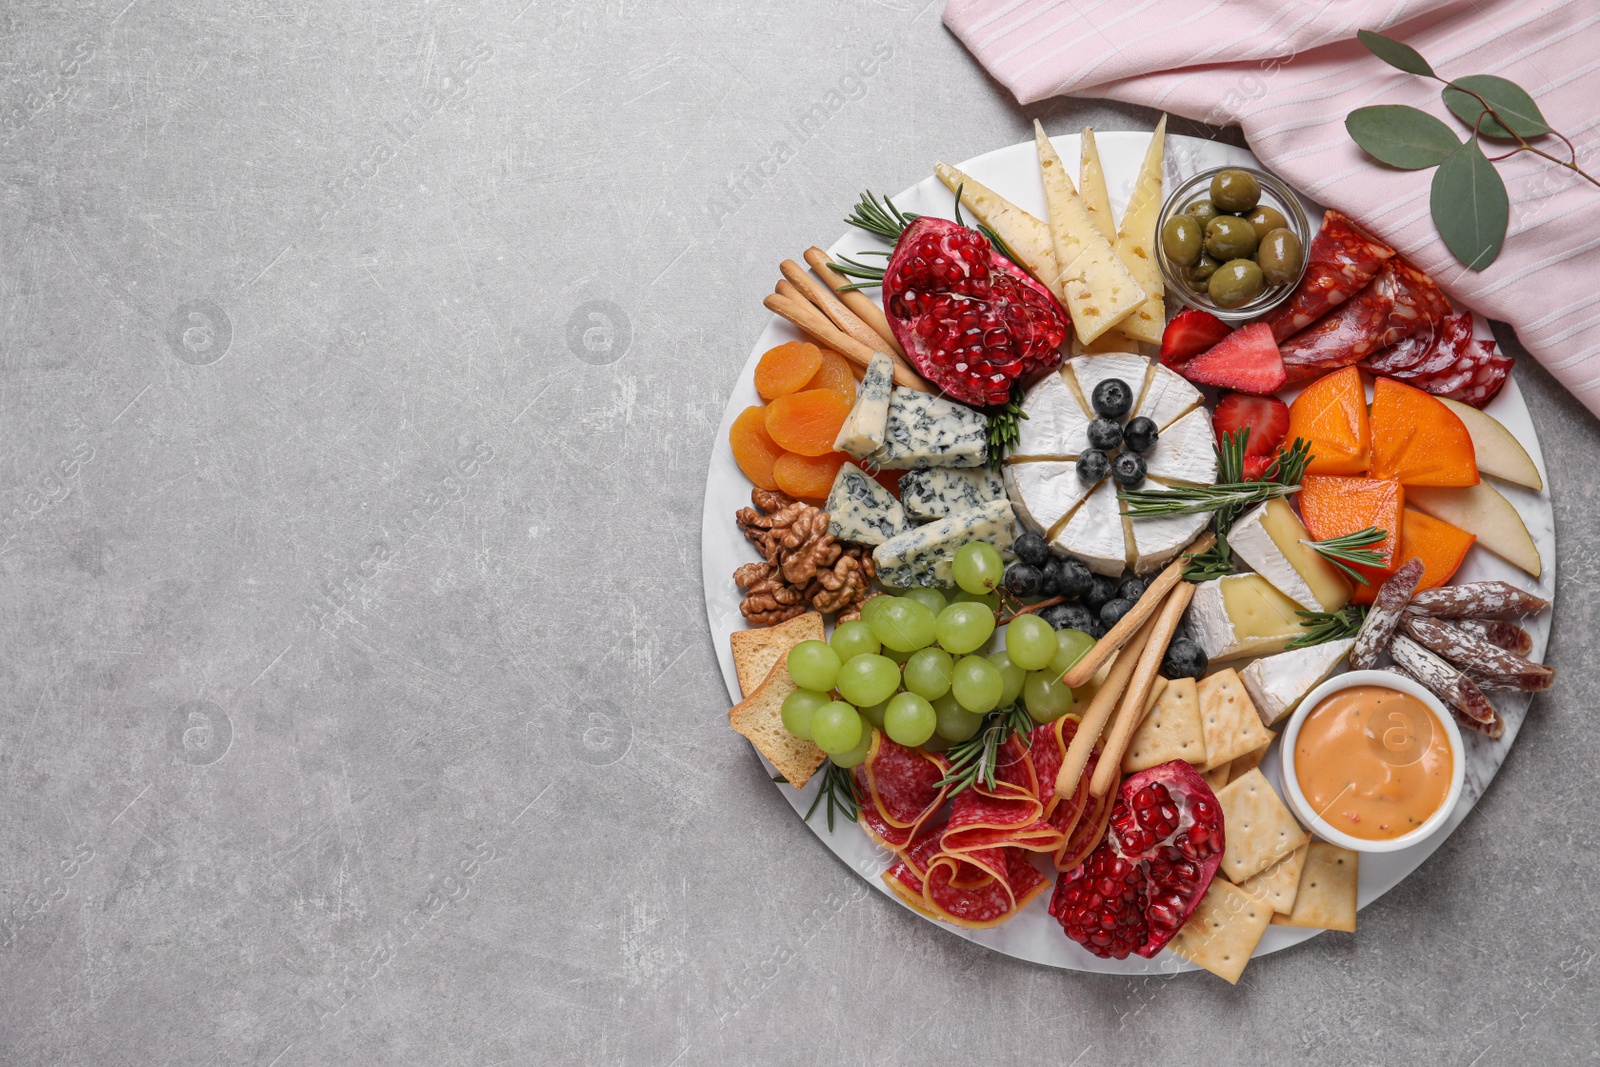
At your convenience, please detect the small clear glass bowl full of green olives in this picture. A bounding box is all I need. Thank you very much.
[1155,166,1310,323]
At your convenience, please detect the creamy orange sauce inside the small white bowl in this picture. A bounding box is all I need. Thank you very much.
[1294,685,1454,841]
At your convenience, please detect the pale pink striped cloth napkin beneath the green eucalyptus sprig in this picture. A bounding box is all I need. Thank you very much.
[944,0,1600,414]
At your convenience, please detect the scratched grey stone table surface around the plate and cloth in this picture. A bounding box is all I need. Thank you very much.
[0,0,1600,1067]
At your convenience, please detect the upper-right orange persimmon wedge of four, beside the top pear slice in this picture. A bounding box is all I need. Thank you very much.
[1371,378,1478,486]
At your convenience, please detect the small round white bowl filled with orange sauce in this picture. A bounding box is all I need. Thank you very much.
[1280,670,1466,853]
